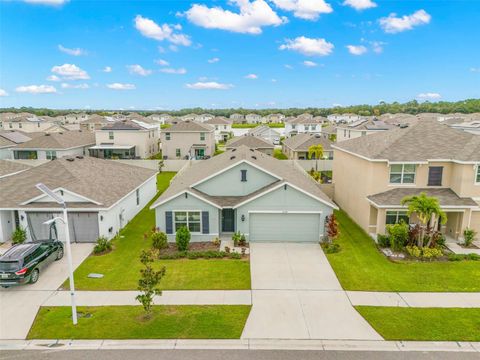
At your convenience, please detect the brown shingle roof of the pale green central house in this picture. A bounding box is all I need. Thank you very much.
[152,145,337,208]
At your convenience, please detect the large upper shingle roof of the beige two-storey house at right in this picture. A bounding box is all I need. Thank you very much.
[333,119,480,162]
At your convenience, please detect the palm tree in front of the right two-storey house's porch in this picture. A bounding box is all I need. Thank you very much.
[401,192,447,247]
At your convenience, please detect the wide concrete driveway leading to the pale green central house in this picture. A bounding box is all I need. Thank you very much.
[242,243,382,340]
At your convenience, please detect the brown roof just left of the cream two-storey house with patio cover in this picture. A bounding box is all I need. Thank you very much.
[16,131,95,150]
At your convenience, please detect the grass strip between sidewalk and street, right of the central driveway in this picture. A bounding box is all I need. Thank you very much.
[355,306,480,341]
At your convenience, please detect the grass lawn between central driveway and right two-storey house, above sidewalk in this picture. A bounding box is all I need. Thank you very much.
[327,211,480,292]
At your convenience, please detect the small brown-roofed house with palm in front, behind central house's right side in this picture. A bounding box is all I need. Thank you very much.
[282,133,333,160]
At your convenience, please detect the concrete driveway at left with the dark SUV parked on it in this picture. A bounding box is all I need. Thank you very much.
[0,244,93,339]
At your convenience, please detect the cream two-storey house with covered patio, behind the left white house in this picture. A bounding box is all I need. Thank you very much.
[89,120,160,159]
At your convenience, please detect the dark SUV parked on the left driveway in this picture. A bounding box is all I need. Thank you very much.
[0,240,64,288]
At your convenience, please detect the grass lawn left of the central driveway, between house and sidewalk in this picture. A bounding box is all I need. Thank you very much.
[70,172,250,290]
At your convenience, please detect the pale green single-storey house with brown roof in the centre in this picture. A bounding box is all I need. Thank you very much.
[151,146,337,243]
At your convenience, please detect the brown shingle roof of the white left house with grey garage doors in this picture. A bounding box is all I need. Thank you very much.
[0,157,156,208]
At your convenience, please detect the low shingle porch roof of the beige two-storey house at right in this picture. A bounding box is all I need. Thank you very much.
[367,188,478,207]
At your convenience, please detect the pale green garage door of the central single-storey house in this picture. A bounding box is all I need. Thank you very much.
[249,213,321,242]
